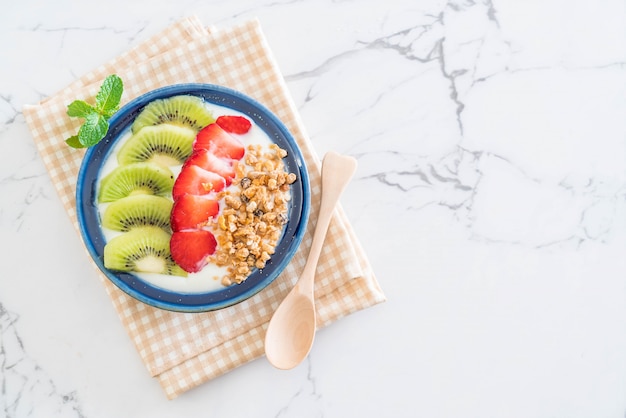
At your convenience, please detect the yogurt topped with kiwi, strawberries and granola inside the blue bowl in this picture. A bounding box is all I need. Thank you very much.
[97,95,296,292]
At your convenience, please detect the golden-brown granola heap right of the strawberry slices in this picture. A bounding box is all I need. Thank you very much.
[212,144,296,286]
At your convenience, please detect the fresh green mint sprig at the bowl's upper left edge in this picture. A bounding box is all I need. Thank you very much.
[65,74,124,148]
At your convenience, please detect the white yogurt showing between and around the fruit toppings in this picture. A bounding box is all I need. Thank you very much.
[97,103,273,293]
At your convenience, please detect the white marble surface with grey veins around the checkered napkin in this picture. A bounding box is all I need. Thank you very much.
[0,0,626,418]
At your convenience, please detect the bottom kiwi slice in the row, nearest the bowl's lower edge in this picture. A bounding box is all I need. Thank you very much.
[104,226,187,276]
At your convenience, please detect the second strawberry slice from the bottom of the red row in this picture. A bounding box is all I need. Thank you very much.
[170,194,220,232]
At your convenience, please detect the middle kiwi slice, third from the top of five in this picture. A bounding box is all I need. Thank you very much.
[98,162,174,202]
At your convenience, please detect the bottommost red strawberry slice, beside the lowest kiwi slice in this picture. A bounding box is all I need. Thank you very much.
[170,229,217,273]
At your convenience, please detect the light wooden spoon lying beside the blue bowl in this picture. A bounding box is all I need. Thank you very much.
[265,151,357,370]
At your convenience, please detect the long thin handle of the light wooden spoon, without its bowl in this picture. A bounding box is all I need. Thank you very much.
[297,151,357,294]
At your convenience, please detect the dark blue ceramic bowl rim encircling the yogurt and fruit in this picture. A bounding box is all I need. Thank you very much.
[76,84,310,312]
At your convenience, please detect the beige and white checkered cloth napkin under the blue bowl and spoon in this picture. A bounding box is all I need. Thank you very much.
[24,17,385,399]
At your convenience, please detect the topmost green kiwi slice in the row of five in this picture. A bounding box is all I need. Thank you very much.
[131,94,215,133]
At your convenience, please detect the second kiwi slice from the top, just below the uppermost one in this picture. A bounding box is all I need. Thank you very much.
[117,124,196,166]
